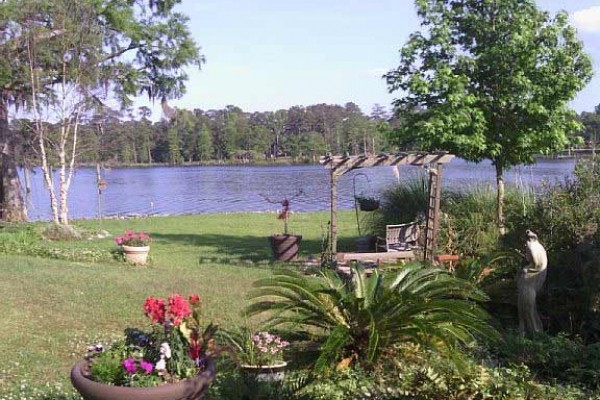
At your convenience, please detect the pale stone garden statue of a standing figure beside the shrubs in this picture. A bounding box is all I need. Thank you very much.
[517,230,548,335]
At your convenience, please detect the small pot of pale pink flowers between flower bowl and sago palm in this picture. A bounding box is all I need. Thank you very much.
[221,326,290,382]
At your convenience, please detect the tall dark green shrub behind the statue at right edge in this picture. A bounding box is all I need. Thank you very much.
[503,160,600,341]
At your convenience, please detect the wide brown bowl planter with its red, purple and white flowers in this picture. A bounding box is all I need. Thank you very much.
[71,294,220,400]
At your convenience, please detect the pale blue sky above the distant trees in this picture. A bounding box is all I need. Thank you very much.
[136,0,600,119]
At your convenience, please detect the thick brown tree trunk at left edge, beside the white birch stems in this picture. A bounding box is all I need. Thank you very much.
[0,94,27,222]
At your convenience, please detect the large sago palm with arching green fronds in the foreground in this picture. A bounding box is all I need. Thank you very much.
[247,264,496,370]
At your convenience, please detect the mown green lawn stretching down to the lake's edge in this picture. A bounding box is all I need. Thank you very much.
[0,212,357,393]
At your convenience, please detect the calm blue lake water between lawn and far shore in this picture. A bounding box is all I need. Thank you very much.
[23,159,575,220]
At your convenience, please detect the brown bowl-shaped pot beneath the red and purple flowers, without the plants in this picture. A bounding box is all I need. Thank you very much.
[71,361,216,400]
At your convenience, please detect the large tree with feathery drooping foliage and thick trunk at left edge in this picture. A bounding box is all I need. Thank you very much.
[0,0,203,219]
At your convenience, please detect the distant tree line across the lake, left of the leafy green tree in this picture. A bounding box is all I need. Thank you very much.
[11,103,394,166]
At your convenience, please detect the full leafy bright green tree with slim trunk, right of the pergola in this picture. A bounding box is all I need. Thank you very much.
[386,0,592,232]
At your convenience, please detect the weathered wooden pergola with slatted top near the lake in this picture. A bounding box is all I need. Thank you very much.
[320,152,455,259]
